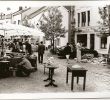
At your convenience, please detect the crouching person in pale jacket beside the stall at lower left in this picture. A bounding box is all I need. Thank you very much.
[16,55,35,77]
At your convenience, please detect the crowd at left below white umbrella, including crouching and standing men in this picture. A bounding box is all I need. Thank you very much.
[2,39,45,76]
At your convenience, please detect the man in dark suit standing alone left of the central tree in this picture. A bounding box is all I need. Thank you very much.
[38,41,45,63]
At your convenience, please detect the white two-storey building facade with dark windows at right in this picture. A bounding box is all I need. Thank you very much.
[75,5,109,54]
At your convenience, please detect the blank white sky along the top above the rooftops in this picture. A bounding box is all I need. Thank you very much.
[0,0,110,14]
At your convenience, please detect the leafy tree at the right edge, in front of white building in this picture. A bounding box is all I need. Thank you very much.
[98,6,110,37]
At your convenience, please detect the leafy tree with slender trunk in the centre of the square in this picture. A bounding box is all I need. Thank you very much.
[40,7,67,52]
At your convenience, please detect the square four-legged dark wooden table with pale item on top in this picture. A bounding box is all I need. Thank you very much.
[66,65,87,90]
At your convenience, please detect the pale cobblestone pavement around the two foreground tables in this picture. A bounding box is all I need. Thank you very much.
[0,52,110,93]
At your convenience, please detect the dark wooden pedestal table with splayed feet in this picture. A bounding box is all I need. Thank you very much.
[44,65,58,87]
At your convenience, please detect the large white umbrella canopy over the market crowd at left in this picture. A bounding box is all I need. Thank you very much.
[0,23,44,36]
